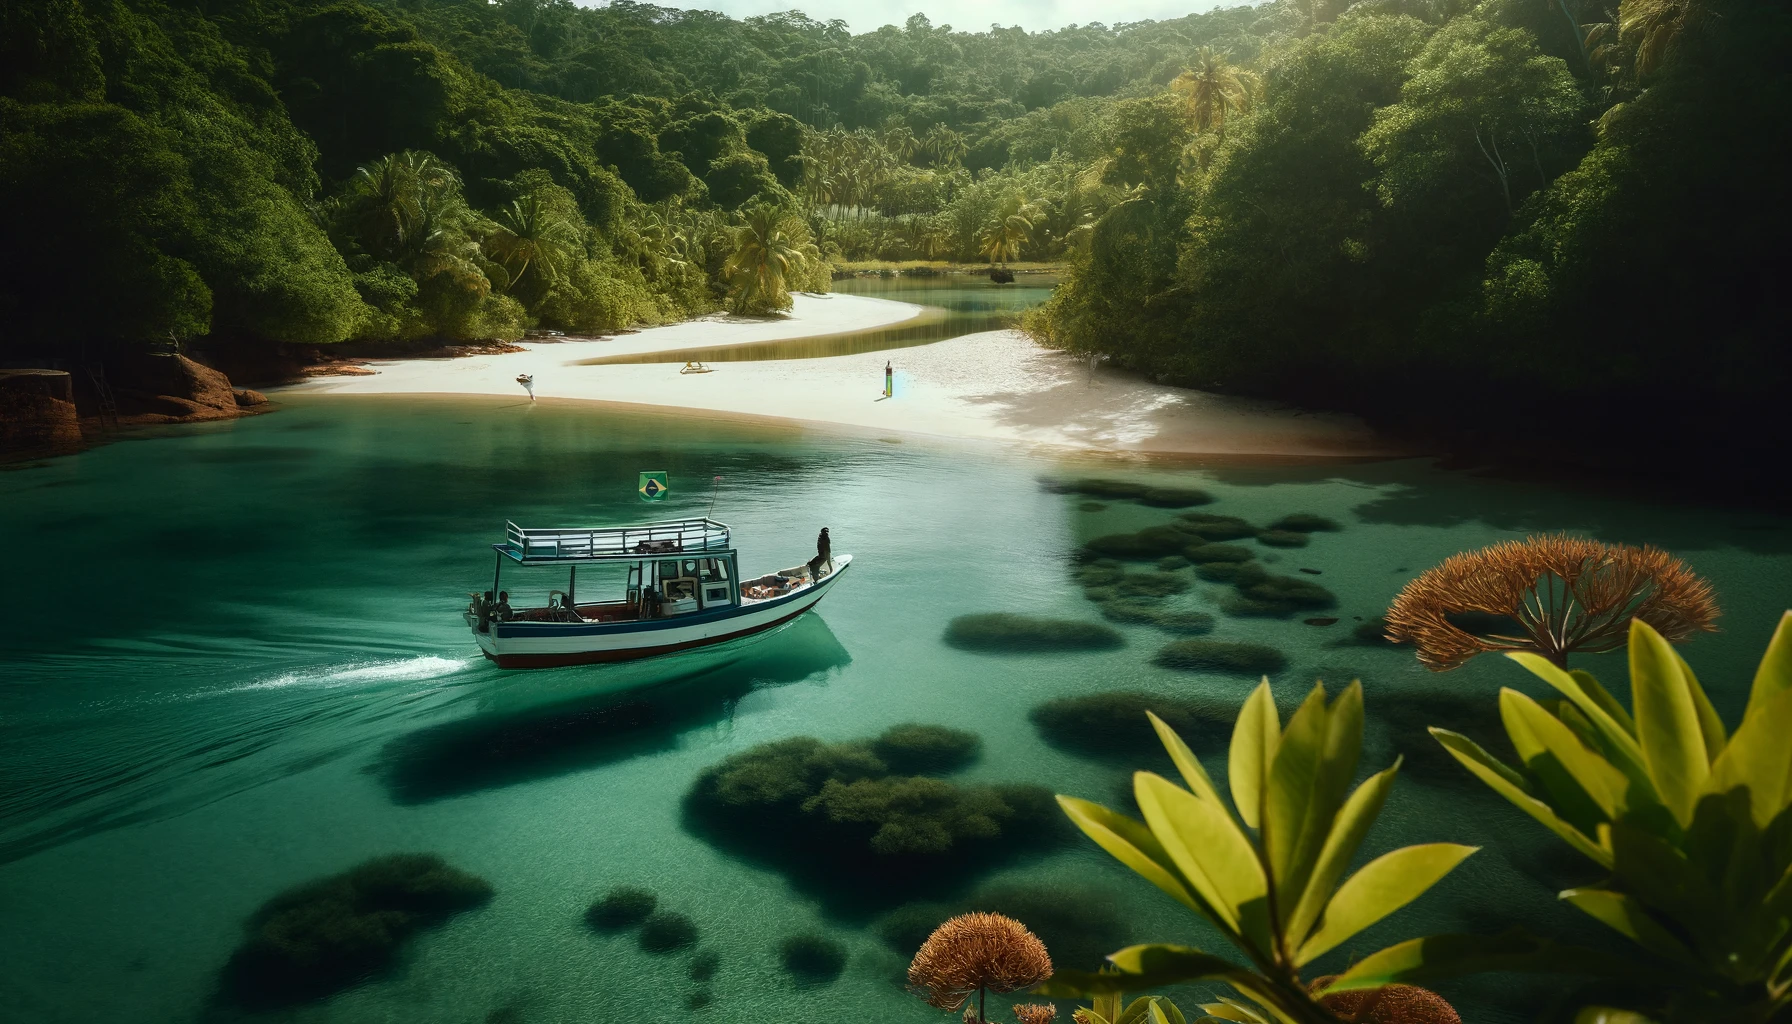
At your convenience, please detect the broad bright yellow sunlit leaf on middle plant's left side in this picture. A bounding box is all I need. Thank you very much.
[1133,771,1271,952]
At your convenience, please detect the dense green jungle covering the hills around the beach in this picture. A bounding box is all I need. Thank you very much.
[0,0,1792,486]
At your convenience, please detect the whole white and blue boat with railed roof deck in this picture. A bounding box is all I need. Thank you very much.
[466,518,853,669]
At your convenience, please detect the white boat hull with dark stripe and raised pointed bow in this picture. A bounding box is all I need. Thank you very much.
[470,554,853,669]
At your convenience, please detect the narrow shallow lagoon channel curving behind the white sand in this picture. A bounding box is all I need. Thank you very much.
[584,274,1057,366]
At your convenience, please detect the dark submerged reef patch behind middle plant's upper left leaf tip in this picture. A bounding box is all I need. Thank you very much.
[1027,690,1233,764]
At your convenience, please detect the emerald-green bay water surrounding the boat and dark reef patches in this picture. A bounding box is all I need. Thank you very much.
[0,396,1792,1024]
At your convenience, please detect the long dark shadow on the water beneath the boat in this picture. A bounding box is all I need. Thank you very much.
[367,613,851,805]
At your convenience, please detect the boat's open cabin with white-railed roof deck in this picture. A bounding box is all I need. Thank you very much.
[468,518,742,633]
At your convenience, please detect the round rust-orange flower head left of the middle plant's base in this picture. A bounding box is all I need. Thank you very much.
[909,913,1052,1010]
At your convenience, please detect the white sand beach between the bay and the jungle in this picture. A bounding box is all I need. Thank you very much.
[285,294,1398,456]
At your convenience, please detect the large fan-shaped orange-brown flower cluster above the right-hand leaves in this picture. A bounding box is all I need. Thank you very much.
[1387,534,1719,673]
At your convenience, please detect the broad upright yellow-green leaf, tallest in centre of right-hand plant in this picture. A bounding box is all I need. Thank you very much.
[1631,619,1711,829]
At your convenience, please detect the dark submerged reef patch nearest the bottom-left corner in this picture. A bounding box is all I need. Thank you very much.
[224,854,491,1008]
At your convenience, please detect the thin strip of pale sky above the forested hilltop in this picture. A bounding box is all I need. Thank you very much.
[579,0,1244,32]
